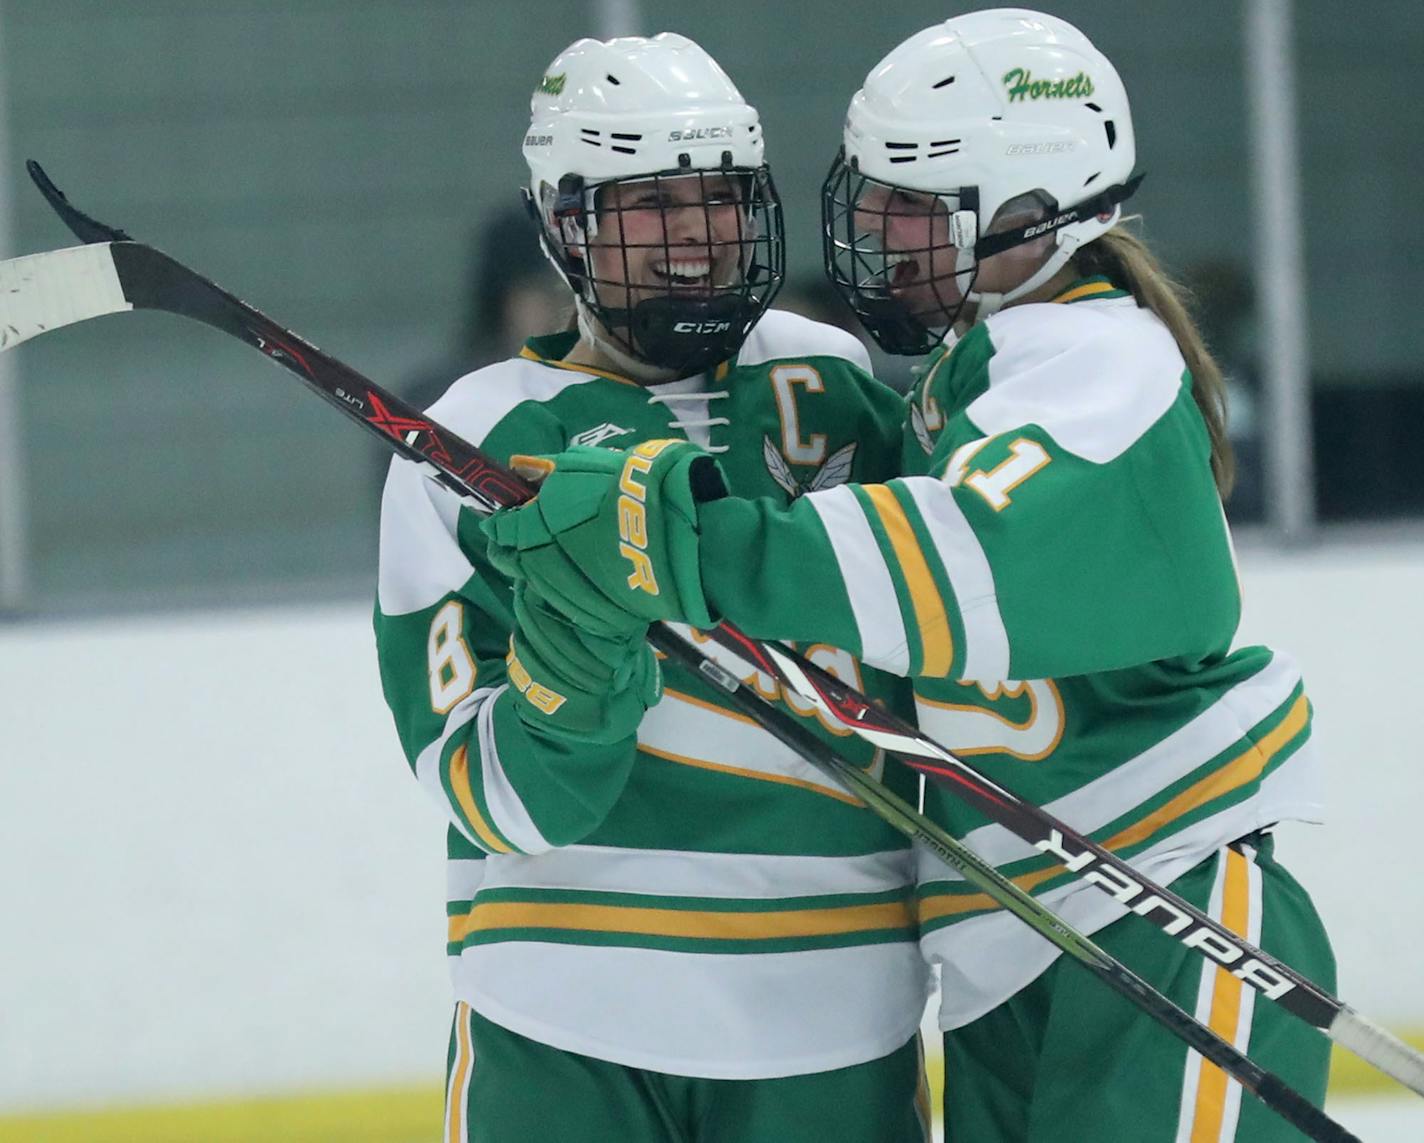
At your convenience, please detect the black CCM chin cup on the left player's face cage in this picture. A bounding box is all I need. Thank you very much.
[605,293,762,377]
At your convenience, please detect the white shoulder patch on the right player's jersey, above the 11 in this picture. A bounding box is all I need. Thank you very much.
[965,297,1186,464]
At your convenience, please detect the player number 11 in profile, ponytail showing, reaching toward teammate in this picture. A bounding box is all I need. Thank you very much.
[487,10,1334,1143]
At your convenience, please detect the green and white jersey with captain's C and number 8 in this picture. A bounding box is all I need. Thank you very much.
[376,312,927,1079]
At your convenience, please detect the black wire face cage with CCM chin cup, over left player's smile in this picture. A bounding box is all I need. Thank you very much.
[553,164,786,377]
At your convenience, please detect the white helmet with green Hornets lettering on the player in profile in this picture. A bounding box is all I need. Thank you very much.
[822,9,1141,353]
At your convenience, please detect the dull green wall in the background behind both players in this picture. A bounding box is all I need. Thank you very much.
[0,0,1424,613]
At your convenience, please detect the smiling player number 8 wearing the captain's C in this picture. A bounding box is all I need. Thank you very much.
[376,34,927,1143]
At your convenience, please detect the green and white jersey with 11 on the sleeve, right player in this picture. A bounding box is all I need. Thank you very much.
[703,279,1320,1028]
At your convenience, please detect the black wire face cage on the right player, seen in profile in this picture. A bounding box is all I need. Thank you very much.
[820,151,978,356]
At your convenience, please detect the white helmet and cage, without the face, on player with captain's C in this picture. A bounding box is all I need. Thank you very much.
[524,31,785,373]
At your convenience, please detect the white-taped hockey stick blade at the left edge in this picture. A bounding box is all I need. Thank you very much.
[0,242,134,350]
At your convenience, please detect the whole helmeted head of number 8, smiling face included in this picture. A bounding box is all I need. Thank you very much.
[524,33,785,376]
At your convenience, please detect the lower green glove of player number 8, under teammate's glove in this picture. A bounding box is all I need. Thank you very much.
[504,582,662,743]
